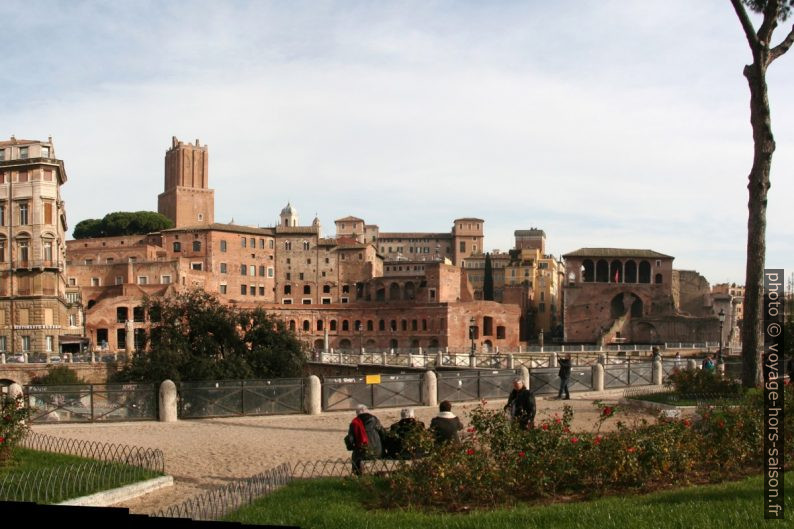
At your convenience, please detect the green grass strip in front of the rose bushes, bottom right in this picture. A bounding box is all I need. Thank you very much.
[226,472,794,529]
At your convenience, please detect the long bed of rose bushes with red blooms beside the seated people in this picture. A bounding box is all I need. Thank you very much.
[377,386,794,511]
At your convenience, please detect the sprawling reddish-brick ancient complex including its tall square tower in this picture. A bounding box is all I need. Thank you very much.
[66,138,520,352]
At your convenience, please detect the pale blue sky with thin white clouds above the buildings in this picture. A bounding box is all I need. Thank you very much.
[0,0,794,284]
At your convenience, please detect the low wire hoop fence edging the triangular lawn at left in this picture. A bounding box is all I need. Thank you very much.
[20,432,165,472]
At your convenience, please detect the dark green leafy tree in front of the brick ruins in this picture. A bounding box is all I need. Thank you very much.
[114,289,306,383]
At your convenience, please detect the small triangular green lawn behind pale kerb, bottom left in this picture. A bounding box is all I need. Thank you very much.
[0,448,162,503]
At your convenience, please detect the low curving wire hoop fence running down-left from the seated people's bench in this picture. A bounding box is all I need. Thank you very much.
[155,458,405,520]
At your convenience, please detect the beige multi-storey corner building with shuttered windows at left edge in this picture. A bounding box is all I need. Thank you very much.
[0,137,70,355]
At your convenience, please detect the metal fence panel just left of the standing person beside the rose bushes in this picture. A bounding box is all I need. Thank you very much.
[437,369,520,402]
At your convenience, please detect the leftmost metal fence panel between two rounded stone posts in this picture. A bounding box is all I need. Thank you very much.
[24,384,158,422]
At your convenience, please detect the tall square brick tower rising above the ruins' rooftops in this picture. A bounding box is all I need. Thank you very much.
[157,137,215,228]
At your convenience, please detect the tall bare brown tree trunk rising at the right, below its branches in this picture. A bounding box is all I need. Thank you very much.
[742,62,775,388]
